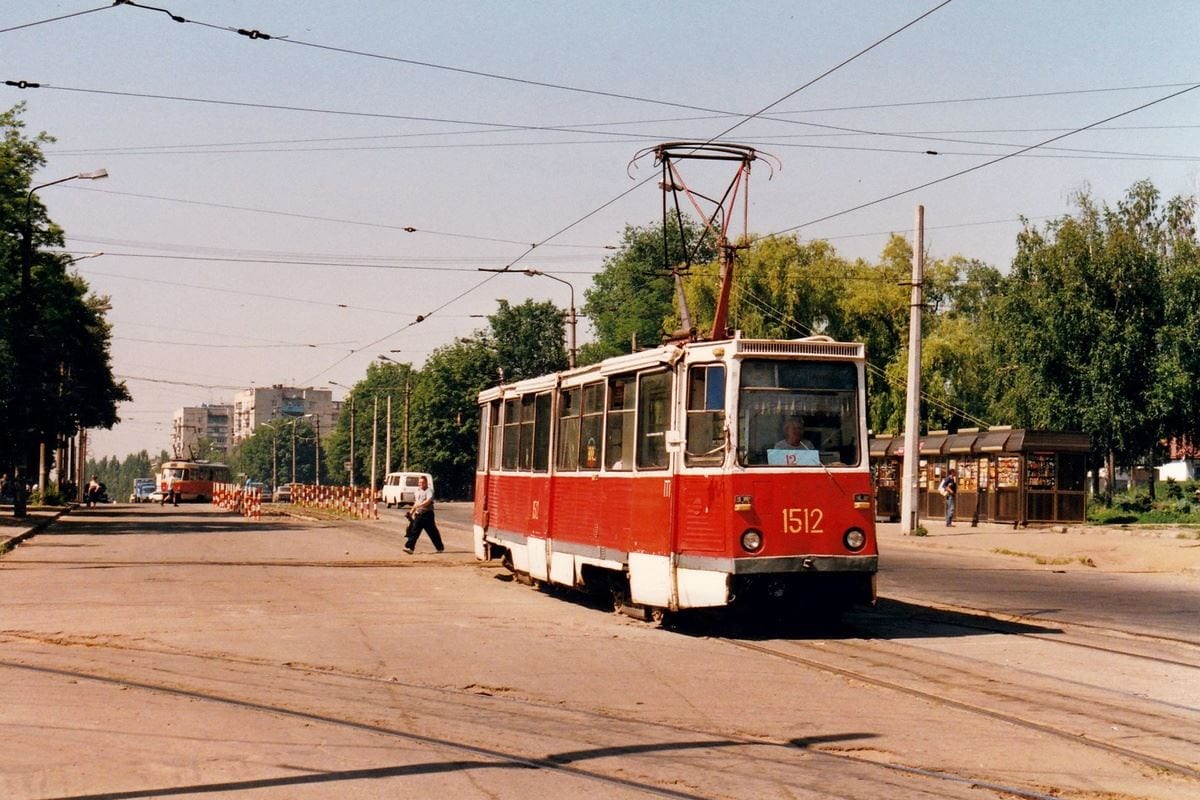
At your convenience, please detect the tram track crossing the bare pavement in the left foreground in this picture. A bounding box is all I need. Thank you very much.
[0,631,1070,800]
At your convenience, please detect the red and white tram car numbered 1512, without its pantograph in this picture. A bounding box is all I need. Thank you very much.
[474,335,878,616]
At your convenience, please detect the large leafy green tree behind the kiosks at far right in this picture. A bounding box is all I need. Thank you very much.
[996,181,1196,499]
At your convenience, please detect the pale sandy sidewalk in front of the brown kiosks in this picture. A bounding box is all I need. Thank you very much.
[876,519,1200,579]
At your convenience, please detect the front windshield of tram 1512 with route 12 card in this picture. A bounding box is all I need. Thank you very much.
[738,359,862,468]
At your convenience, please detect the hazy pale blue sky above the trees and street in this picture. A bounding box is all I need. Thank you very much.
[0,0,1200,456]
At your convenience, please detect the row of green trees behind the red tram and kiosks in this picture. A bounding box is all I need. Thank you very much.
[229,188,1200,497]
